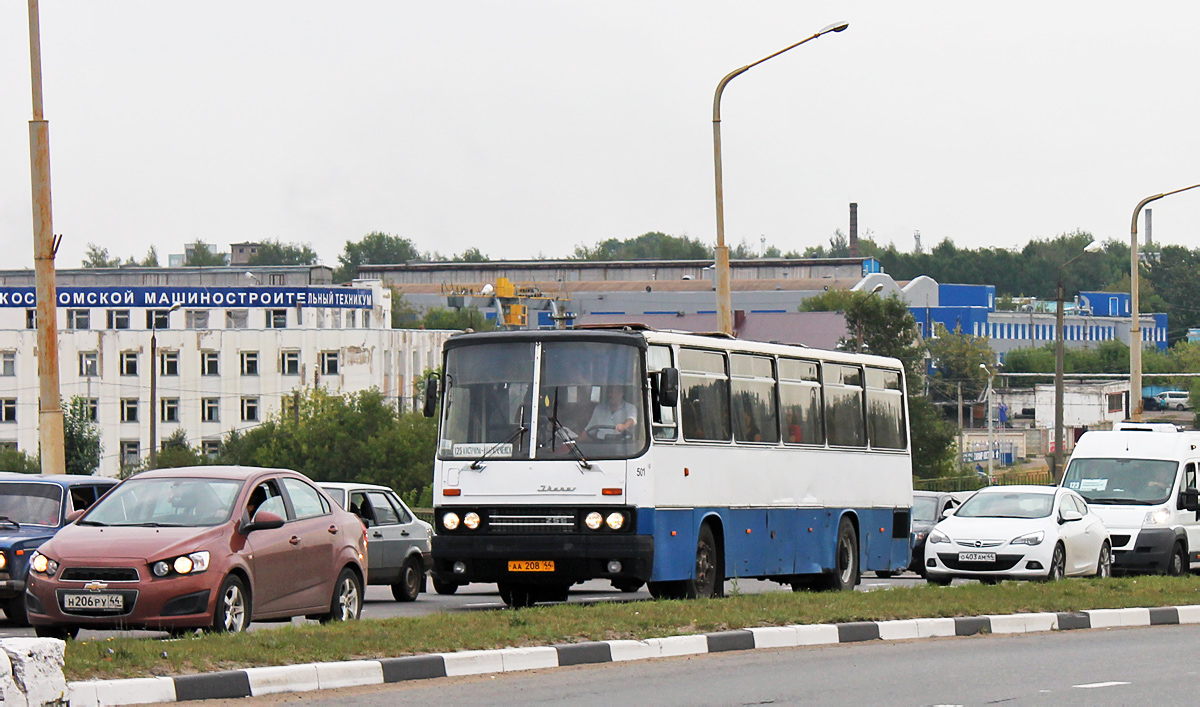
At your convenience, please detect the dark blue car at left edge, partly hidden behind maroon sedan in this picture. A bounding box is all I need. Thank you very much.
[0,474,118,625]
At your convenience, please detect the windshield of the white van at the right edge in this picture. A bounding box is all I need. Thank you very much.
[1062,457,1180,505]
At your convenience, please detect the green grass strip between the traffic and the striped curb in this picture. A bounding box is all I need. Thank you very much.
[66,575,1200,681]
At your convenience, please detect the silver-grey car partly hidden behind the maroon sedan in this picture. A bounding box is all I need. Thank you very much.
[320,481,433,601]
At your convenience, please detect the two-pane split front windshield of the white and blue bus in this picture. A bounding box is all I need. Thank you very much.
[438,341,646,460]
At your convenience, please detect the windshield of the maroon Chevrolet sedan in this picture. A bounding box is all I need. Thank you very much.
[79,477,241,527]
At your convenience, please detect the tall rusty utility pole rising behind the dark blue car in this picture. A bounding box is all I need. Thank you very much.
[29,0,66,474]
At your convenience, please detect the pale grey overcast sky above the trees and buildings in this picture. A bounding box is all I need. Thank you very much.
[0,0,1200,268]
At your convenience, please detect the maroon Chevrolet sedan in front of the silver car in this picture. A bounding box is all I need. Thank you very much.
[25,466,367,637]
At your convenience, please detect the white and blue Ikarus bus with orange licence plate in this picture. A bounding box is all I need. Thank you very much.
[426,326,912,606]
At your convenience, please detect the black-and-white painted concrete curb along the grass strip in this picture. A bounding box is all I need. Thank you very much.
[67,605,1200,707]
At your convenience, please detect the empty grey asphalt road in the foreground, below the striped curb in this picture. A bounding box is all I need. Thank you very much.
[177,627,1200,707]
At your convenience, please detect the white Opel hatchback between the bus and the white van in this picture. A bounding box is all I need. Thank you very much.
[925,486,1112,585]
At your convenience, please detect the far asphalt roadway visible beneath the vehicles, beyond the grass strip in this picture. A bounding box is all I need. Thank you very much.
[0,574,924,639]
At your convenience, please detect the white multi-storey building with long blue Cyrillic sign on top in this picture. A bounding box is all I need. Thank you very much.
[0,278,454,475]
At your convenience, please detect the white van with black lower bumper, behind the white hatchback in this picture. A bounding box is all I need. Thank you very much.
[1062,423,1200,575]
